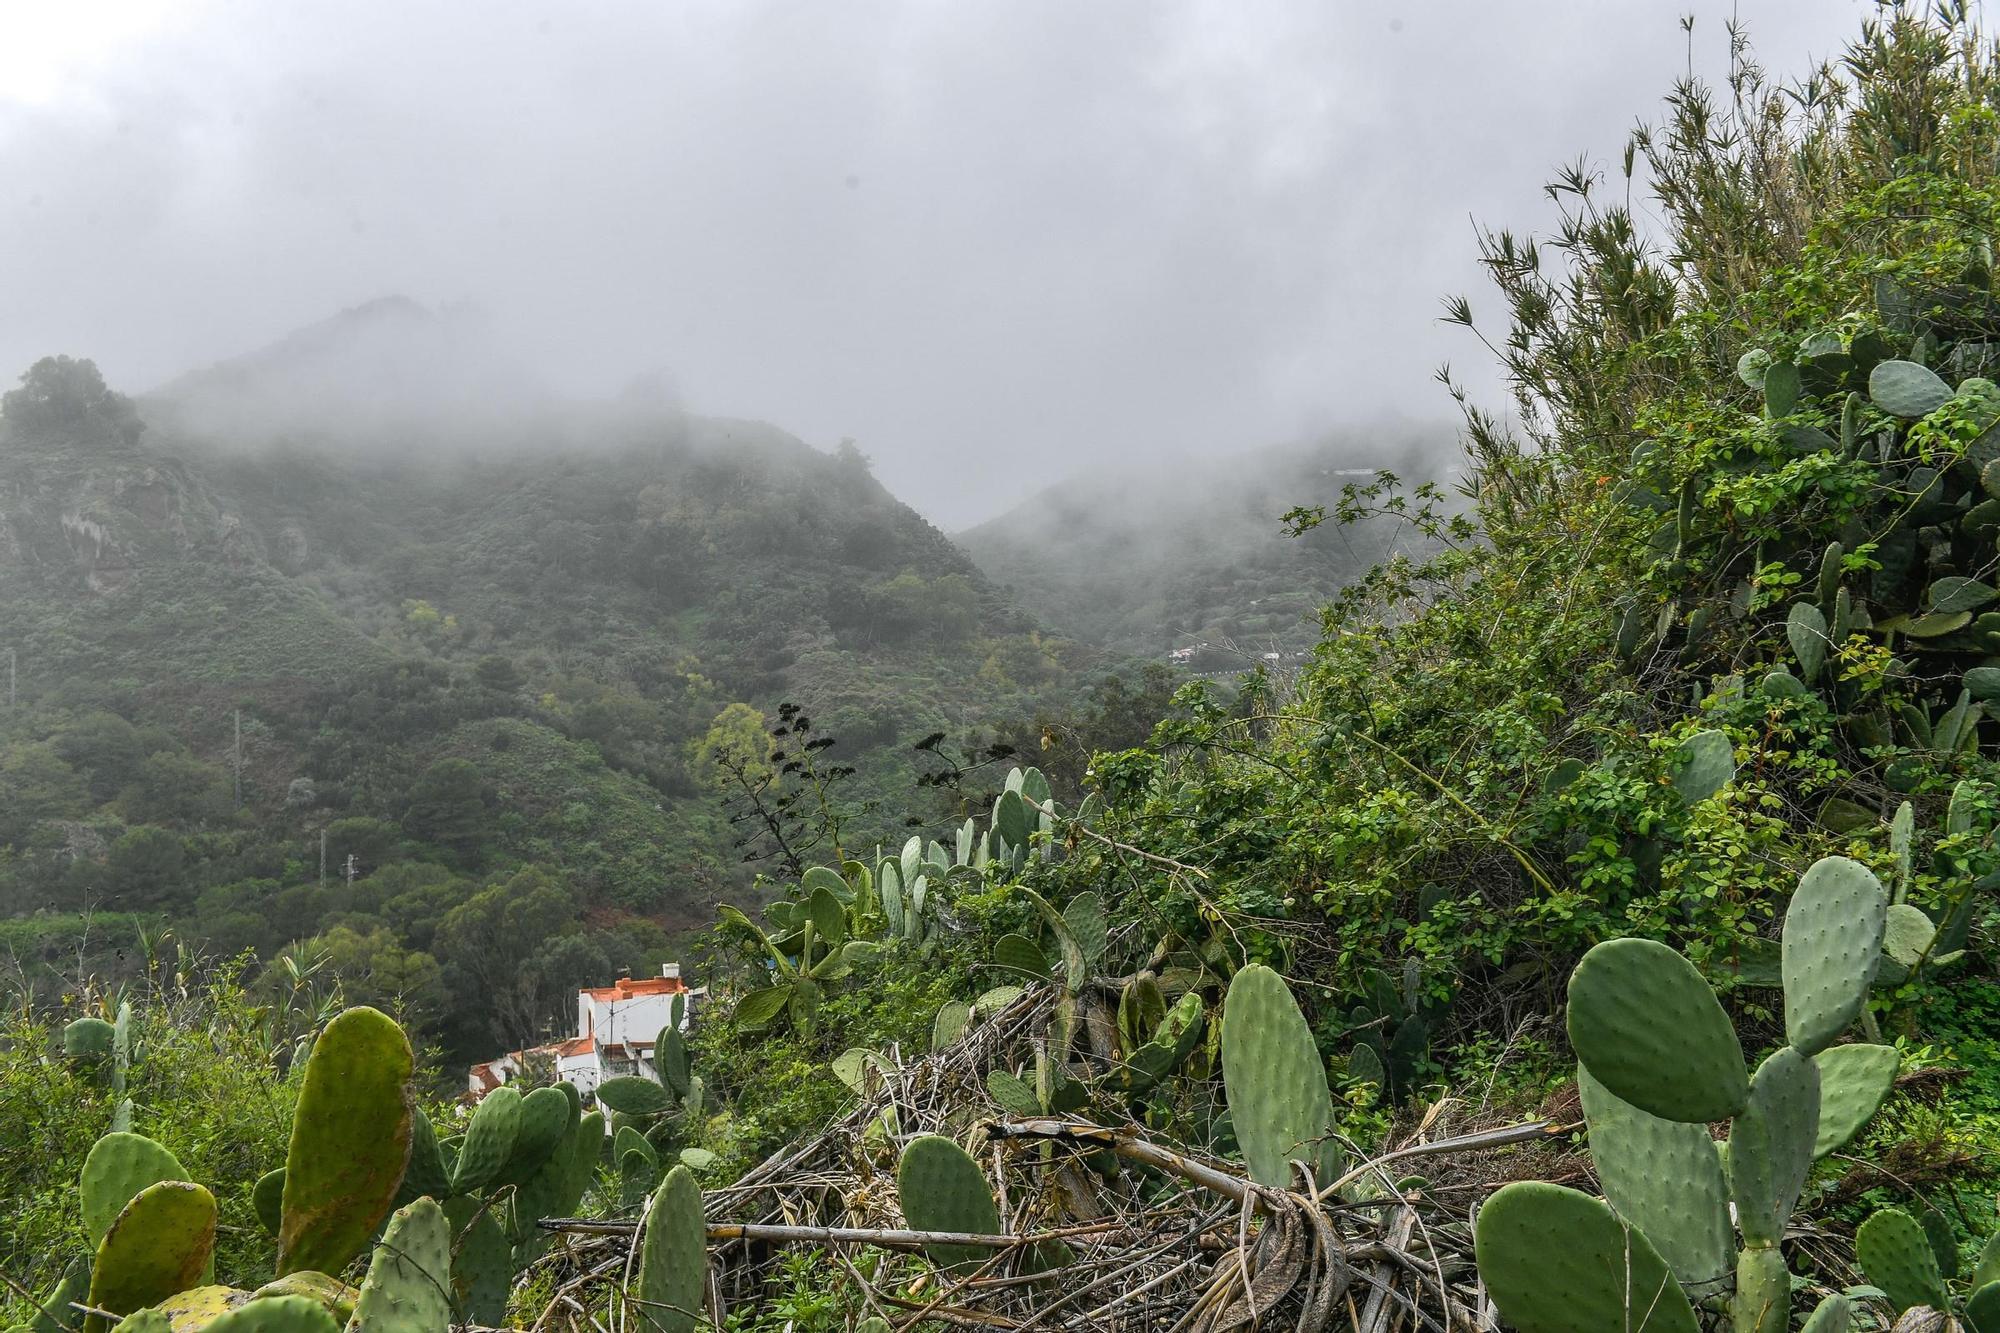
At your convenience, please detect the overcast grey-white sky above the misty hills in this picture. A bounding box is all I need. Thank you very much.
[0,0,1870,526]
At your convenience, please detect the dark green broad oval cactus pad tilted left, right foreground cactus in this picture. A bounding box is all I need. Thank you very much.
[1568,939,1750,1125]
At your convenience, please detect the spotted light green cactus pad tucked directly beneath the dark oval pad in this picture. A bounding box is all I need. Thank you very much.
[1576,1047,1736,1291]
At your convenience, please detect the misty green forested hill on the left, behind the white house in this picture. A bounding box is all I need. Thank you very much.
[0,302,1140,1057]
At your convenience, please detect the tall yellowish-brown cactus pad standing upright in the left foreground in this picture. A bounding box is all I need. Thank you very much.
[278,1009,414,1277]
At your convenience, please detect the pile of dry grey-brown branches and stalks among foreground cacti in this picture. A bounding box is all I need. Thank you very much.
[536,991,1566,1333]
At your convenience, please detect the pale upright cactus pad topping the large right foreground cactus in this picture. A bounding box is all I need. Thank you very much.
[1782,857,1888,1055]
